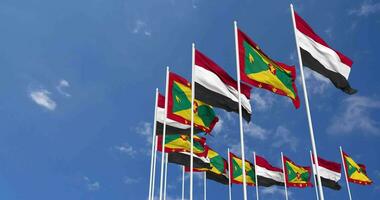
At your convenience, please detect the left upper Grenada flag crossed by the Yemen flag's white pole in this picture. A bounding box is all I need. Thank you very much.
[168,72,219,133]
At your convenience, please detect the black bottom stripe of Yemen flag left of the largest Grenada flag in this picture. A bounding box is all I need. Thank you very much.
[195,83,251,122]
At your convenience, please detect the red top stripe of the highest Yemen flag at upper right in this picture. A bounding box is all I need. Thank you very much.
[294,11,353,67]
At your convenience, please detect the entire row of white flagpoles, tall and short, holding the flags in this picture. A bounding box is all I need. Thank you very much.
[145,4,362,200]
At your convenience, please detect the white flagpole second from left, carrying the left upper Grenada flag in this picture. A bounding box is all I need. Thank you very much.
[160,67,169,200]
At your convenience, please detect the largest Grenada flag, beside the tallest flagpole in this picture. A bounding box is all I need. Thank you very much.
[238,30,300,108]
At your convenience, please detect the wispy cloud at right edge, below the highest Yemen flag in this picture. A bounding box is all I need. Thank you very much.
[327,95,380,135]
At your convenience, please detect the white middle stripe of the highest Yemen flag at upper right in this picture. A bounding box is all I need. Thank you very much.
[296,30,351,80]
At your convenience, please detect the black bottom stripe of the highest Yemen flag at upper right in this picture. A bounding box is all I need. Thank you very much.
[300,48,357,94]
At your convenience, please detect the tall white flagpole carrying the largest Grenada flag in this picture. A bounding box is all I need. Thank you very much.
[234,21,247,200]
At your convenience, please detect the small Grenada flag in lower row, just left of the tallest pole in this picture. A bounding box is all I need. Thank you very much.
[283,156,312,188]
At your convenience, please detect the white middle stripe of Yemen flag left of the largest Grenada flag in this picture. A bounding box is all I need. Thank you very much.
[194,65,252,114]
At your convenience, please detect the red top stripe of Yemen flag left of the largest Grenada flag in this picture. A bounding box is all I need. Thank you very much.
[195,49,251,99]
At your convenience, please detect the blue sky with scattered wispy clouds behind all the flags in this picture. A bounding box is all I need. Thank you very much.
[0,0,380,200]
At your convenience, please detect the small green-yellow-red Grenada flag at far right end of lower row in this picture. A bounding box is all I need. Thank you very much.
[343,152,372,185]
